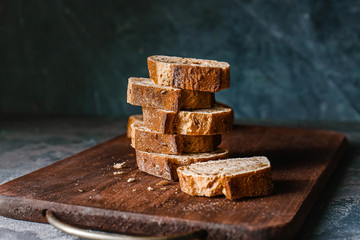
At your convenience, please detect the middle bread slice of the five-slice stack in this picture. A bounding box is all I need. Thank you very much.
[143,103,234,135]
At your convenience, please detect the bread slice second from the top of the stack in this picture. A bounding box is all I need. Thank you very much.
[127,77,215,112]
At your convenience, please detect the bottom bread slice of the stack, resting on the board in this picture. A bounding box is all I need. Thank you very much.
[136,148,228,180]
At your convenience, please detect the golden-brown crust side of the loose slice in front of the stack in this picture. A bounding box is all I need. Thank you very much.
[177,157,274,199]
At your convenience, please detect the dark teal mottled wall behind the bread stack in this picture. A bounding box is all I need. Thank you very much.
[0,0,360,121]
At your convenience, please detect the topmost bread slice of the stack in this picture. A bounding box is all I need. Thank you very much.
[147,56,230,92]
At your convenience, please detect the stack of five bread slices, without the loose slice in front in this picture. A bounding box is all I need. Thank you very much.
[127,56,233,180]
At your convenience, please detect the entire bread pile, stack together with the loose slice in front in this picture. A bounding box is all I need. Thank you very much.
[127,56,273,199]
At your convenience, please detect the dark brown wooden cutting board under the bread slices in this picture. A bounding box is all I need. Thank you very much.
[0,125,346,239]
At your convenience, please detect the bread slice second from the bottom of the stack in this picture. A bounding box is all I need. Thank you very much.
[131,122,221,154]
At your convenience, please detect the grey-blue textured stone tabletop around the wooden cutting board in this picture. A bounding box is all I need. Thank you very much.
[0,117,360,240]
